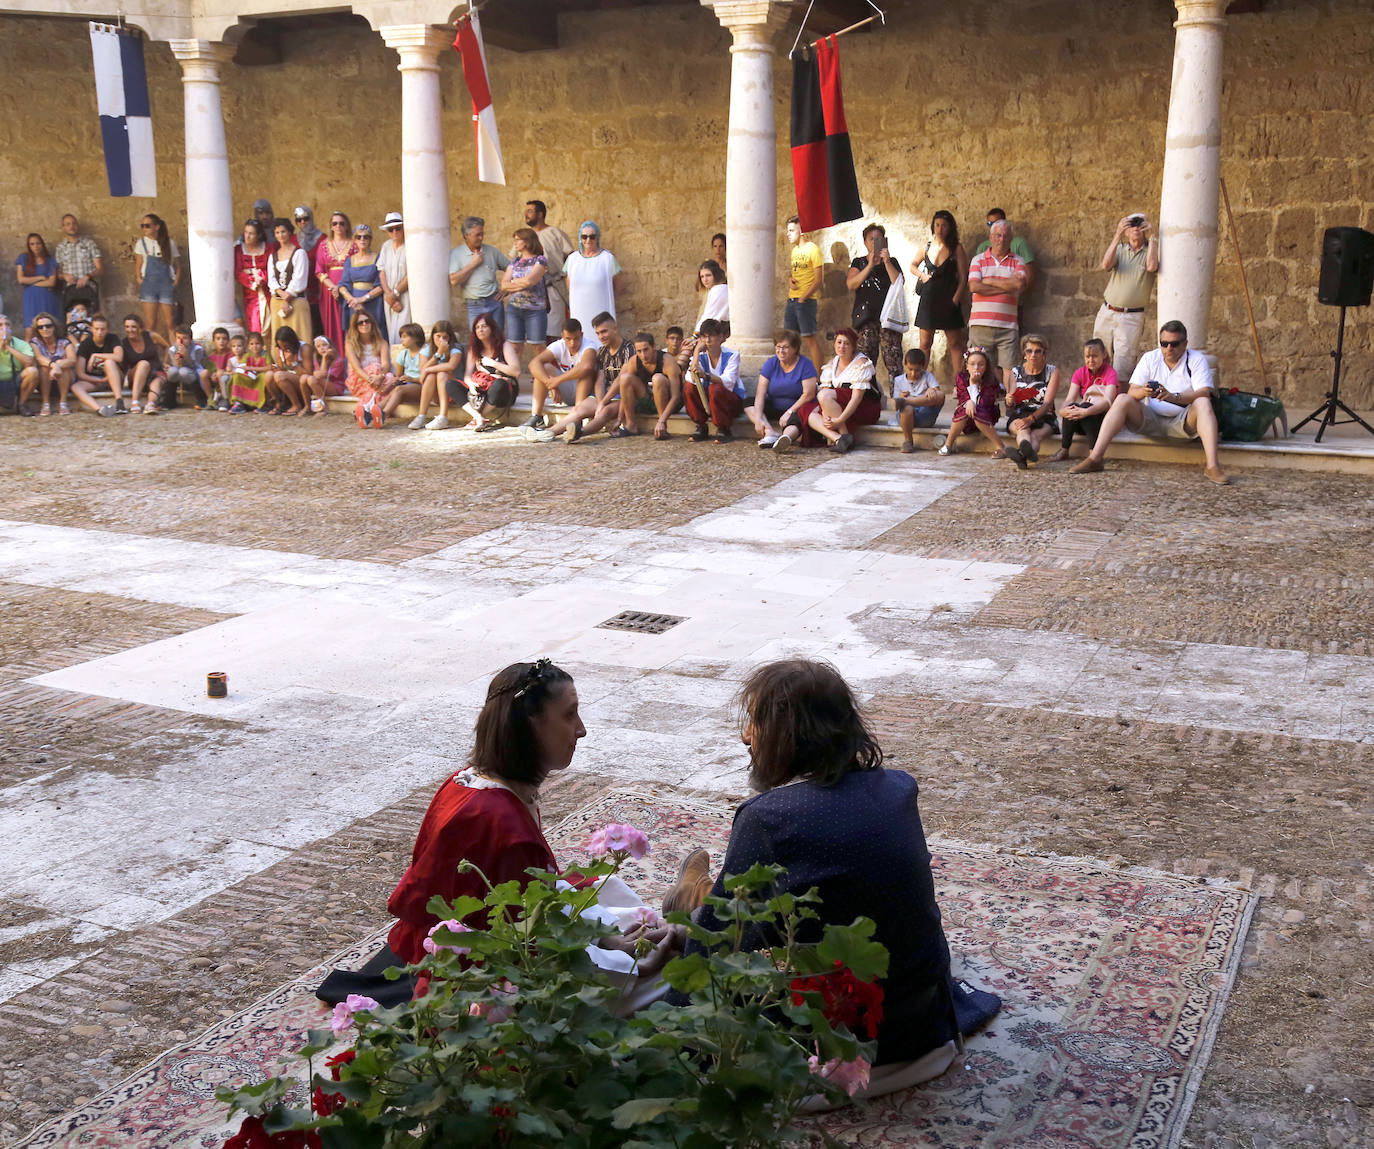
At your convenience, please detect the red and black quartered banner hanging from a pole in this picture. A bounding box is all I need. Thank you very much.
[791,36,863,231]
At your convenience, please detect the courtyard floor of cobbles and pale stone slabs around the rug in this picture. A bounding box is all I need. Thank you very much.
[0,412,1374,1148]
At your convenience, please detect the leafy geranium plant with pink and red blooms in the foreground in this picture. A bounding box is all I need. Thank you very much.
[221,826,888,1149]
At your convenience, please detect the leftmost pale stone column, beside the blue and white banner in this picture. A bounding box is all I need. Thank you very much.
[168,40,243,338]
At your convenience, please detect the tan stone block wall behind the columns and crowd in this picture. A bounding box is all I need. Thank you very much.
[0,0,1374,414]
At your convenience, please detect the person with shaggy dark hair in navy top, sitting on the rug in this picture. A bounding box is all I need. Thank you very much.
[669,660,1000,1095]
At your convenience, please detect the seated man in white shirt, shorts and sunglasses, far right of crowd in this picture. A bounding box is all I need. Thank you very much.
[1069,319,1231,487]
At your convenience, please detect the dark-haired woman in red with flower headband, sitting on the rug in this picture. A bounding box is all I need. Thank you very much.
[316,658,676,1005]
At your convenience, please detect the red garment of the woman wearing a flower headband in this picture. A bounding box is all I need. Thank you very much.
[386,774,558,962]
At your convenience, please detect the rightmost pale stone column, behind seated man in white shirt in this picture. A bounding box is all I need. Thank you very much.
[1158,0,1227,350]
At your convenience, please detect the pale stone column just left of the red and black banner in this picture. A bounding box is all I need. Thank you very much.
[702,0,791,370]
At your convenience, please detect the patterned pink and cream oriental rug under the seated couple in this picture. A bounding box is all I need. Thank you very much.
[16,786,1254,1149]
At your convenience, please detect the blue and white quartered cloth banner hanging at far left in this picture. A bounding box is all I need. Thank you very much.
[91,23,158,195]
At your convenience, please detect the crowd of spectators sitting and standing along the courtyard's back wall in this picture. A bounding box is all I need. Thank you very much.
[0,199,1226,482]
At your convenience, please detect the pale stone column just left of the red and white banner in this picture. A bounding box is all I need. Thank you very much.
[379,23,453,331]
